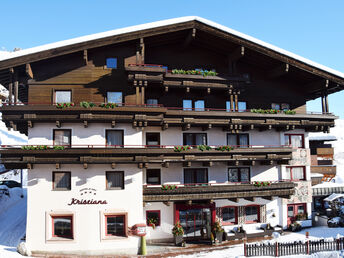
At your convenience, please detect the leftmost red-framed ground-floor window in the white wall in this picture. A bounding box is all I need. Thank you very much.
[51,215,73,239]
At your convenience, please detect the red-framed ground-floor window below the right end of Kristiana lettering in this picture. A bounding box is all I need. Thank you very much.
[105,215,127,237]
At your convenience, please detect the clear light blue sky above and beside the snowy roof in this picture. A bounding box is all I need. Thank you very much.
[0,0,344,118]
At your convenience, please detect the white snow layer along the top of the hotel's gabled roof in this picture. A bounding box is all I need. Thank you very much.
[0,16,344,78]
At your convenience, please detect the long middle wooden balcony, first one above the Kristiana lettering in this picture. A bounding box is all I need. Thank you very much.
[0,145,292,169]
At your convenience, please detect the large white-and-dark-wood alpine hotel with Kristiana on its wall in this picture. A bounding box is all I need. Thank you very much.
[0,17,344,254]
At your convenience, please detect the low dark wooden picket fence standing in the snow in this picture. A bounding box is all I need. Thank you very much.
[244,238,344,257]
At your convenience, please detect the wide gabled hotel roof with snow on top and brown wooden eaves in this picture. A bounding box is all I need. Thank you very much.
[0,16,344,98]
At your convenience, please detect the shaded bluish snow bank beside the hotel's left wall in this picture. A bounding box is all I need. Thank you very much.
[0,187,27,258]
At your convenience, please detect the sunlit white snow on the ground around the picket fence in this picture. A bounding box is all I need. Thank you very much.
[176,227,344,258]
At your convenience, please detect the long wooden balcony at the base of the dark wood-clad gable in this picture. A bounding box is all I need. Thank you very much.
[0,105,337,133]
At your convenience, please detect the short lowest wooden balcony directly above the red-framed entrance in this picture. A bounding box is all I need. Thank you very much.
[143,182,296,202]
